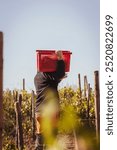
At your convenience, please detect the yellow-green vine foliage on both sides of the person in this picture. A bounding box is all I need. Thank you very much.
[3,87,99,150]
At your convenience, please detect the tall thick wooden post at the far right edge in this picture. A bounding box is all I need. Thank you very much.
[94,71,100,139]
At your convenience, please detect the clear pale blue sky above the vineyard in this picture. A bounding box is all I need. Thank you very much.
[0,0,100,90]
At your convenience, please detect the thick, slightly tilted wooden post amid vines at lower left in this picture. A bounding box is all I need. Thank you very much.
[15,95,24,150]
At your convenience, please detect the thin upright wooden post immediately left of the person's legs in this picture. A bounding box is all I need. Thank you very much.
[31,90,35,140]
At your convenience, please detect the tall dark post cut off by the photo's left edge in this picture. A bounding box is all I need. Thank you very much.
[0,32,3,150]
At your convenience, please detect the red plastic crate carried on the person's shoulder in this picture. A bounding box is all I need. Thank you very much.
[36,50,72,72]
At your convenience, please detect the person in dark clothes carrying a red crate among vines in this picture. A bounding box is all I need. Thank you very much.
[34,51,65,150]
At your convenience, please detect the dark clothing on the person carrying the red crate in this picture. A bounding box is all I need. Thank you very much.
[34,60,65,111]
